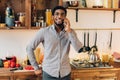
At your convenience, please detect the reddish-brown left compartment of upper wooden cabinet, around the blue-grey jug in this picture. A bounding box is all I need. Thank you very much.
[0,0,26,29]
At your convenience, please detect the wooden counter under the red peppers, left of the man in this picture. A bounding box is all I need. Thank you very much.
[0,68,41,80]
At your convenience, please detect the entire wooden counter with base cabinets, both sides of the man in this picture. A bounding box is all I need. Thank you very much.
[0,63,120,80]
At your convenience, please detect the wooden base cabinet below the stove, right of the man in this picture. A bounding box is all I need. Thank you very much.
[71,68,120,80]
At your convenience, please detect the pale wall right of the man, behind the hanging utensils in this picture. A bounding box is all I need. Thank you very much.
[67,10,120,57]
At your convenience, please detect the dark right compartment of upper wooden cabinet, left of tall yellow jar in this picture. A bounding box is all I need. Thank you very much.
[30,0,59,28]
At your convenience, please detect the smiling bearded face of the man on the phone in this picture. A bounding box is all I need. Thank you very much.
[53,9,66,26]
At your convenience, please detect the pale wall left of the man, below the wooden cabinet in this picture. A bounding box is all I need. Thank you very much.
[0,30,37,59]
